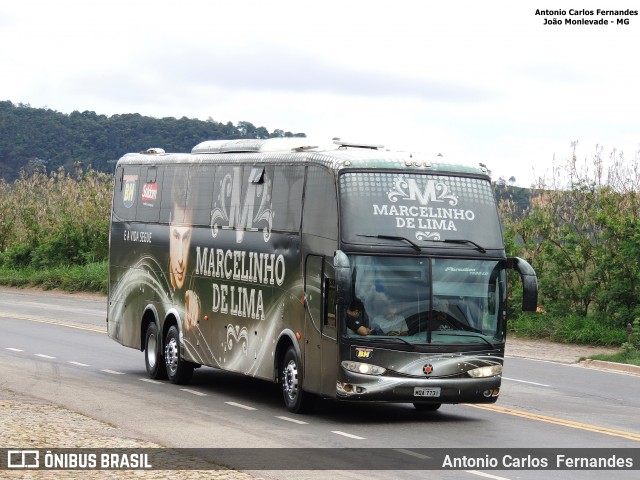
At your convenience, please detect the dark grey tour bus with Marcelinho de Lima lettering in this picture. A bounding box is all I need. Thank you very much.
[107,138,537,413]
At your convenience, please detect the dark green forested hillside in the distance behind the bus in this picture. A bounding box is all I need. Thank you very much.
[0,101,306,181]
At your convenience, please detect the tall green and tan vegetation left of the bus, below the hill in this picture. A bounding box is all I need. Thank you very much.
[0,167,112,293]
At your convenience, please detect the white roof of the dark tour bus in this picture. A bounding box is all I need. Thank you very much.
[118,137,490,176]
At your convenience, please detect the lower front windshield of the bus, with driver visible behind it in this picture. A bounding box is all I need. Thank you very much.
[343,255,506,346]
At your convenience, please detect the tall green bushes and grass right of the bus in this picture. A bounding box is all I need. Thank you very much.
[500,145,640,362]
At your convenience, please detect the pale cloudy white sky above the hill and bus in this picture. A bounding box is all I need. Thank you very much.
[0,0,640,187]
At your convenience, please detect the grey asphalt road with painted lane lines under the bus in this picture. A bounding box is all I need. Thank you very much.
[0,289,640,479]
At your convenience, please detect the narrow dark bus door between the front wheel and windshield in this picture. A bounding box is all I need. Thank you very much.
[302,255,323,393]
